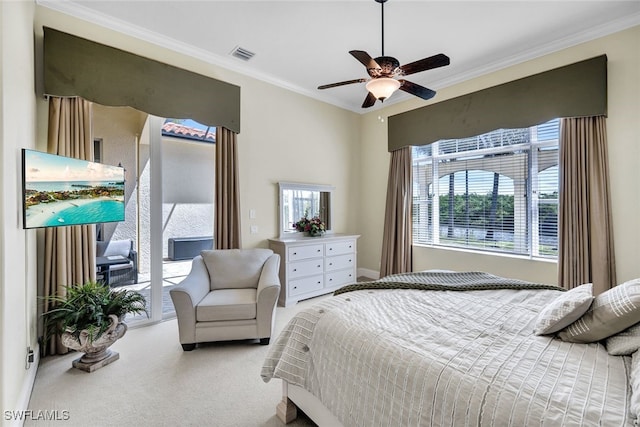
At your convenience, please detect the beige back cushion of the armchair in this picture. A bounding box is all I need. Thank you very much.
[201,249,273,290]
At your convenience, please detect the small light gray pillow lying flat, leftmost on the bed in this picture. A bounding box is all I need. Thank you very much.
[533,283,593,335]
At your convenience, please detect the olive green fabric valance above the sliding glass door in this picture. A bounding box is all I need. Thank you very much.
[44,27,240,133]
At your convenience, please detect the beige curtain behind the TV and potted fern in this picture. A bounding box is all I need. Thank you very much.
[43,97,96,355]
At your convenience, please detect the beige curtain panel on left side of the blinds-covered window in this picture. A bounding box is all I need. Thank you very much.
[380,147,413,277]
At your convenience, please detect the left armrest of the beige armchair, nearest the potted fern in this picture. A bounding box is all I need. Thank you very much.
[169,256,210,344]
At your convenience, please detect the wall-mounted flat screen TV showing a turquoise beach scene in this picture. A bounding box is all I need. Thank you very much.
[22,149,125,228]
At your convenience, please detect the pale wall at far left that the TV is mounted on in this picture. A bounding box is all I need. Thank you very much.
[0,2,37,425]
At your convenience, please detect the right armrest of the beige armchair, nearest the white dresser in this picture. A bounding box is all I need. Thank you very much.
[256,254,280,338]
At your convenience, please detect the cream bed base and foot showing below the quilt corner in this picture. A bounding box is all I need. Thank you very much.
[276,380,342,427]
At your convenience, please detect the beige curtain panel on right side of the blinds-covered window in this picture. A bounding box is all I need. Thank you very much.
[558,116,616,294]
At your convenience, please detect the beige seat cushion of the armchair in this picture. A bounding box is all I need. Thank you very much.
[196,288,256,322]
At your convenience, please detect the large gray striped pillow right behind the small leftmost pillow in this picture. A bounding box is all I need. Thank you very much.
[558,279,640,343]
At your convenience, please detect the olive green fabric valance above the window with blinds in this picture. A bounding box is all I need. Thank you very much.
[388,55,607,151]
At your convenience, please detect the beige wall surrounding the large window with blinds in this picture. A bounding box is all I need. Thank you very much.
[357,27,640,283]
